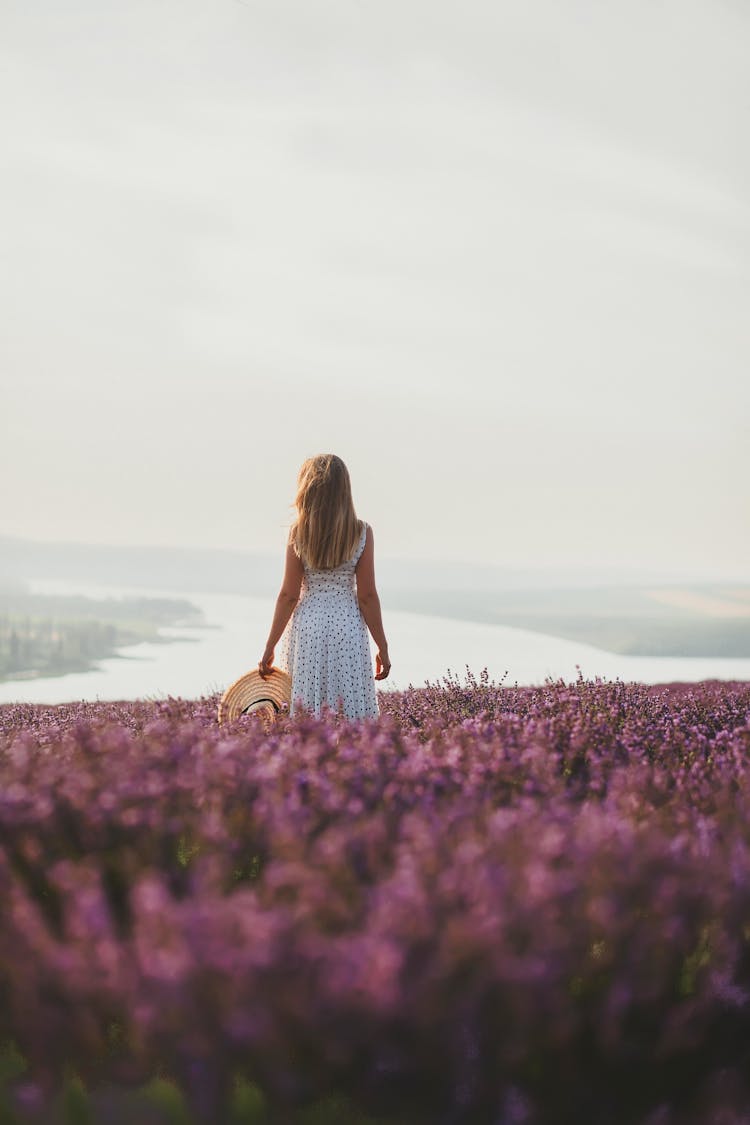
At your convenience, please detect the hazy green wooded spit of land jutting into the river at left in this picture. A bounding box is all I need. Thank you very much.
[0,585,205,682]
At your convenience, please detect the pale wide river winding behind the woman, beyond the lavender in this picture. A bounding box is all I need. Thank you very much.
[0,579,750,703]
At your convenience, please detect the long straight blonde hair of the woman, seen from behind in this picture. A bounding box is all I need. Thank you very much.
[289,453,362,570]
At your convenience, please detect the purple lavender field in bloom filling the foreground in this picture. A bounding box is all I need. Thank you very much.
[0,675,750,1125]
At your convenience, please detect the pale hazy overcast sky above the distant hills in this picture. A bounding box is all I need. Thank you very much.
[0,0,750,578]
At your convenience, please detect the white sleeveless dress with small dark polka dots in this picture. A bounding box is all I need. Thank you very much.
[279,522,380,719]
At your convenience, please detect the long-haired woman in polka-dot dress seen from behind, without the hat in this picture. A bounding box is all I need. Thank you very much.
[259,453,390,719]
